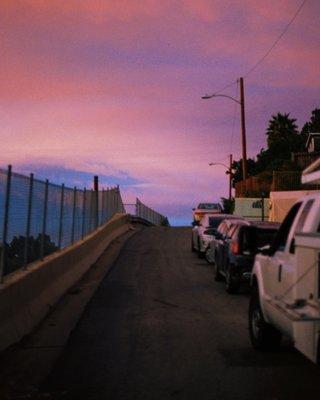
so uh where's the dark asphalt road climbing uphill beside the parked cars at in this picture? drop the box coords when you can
[41,228,320,400]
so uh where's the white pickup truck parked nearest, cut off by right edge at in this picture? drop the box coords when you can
[249,193,320,364]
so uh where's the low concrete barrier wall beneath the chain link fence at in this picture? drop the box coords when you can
[0,214,131,351]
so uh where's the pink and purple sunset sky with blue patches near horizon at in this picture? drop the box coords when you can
[0,0,320,225]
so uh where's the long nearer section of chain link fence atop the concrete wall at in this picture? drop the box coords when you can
[0,166,125,282]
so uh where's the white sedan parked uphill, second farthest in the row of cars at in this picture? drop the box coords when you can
[191,214,238,257]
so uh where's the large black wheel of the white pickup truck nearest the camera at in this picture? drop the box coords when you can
[249,288,282,351]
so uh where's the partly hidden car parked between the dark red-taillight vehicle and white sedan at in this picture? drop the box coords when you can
[205,215,249,268]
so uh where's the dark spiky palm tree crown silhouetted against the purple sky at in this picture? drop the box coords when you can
[266,113,298,148]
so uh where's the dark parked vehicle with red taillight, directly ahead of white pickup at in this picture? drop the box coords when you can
[215,221,279,293]
